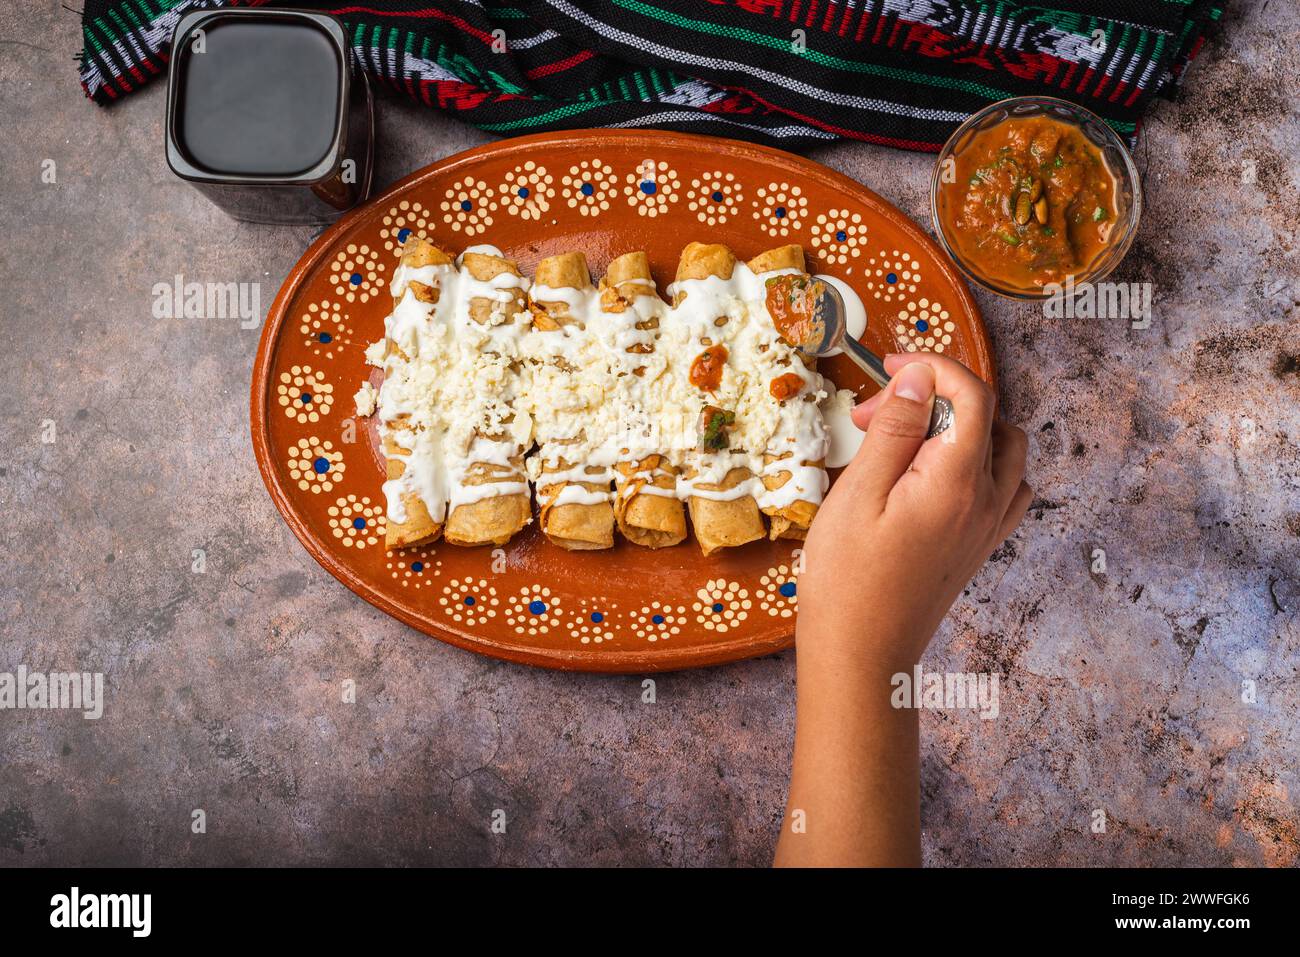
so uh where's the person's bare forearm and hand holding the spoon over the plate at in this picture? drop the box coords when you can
[776,354,1032,866]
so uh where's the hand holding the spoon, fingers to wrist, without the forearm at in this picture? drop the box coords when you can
[798,354,1032,674]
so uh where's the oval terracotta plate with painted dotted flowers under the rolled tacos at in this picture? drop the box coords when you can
[252,130,993,671]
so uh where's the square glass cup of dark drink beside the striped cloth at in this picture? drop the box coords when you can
[165,8,374,224]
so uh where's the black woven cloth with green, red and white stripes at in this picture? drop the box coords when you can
[81,0,1222,151]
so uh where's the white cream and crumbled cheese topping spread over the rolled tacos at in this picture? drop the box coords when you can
[367,246,865,521]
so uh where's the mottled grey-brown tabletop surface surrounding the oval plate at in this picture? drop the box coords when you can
[0,0,1300,865]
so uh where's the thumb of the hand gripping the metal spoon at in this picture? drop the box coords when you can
[854,363,935,499]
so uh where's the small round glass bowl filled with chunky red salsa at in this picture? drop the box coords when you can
[931,96,1141,299]
